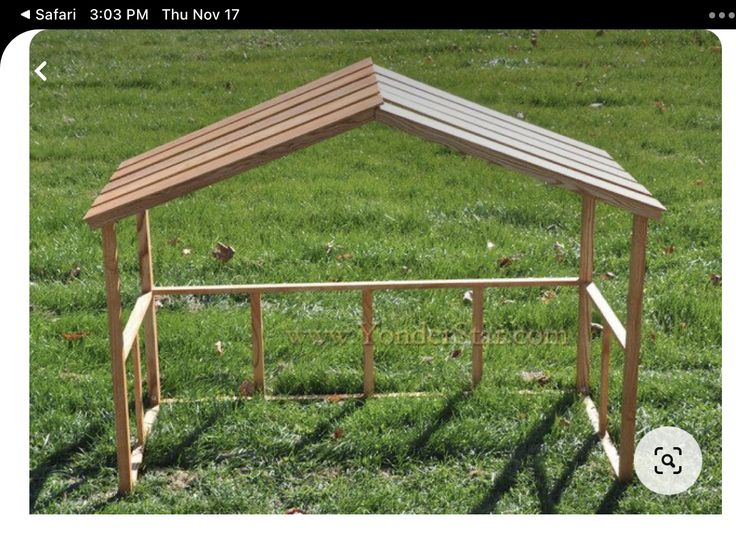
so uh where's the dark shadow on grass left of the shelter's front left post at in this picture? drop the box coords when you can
[30,422,104,513]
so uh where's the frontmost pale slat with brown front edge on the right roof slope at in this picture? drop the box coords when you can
[376,104,664,219]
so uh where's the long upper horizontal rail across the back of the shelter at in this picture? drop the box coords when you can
[154,277,580,296]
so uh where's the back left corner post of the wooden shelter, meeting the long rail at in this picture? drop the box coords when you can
[136,210,161,407]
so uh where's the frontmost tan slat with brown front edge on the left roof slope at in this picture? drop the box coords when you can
[85,95,381,228]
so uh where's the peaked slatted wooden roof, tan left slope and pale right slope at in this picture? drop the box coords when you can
[85,59,665,228]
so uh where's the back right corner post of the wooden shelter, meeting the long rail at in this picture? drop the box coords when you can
[576,195,595,394]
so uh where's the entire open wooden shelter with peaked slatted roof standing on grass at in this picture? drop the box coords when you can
[85,59,665,493]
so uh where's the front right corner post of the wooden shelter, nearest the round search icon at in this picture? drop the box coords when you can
[619,216,647,482]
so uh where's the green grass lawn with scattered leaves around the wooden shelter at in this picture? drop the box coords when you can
[29,31,721,513]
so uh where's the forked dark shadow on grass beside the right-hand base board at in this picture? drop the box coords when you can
[470,392,576,513]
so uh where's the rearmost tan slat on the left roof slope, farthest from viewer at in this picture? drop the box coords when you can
[120,58,373,168]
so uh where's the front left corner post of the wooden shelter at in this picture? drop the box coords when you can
[102,223,133,494]
